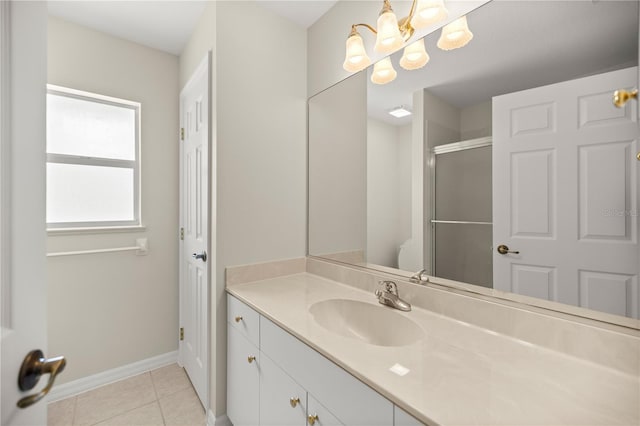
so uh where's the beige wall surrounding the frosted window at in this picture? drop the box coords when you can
[47,18,178,382]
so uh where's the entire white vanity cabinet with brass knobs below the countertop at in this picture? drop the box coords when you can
[227,295,420,426]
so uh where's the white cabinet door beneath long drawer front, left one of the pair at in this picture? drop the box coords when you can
[260,354,307,426]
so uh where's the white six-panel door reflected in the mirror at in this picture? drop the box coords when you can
[493,67,640,318]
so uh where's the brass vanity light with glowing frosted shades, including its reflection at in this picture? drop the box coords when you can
[342,0,473,84]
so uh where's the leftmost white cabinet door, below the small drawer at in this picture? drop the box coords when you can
[227,325,260,426]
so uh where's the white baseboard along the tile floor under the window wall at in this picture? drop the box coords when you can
[47,351,178,402]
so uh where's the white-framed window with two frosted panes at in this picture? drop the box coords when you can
[47,85,140,229]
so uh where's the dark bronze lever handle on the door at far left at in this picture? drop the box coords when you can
[17,349,67,408]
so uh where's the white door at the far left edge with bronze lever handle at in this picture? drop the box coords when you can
[0,2,50,426]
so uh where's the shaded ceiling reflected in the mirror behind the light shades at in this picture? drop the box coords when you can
[367,0,638,124]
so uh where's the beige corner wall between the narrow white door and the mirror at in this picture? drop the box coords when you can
[179,1,307,416]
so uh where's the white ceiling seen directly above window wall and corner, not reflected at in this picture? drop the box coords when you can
[48,0,337,55]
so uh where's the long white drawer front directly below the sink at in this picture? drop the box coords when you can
[260,317,393,426]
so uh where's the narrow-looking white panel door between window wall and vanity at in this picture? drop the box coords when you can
[180,56,212,408]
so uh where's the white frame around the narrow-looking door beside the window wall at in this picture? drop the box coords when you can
[178,50,217,412]
